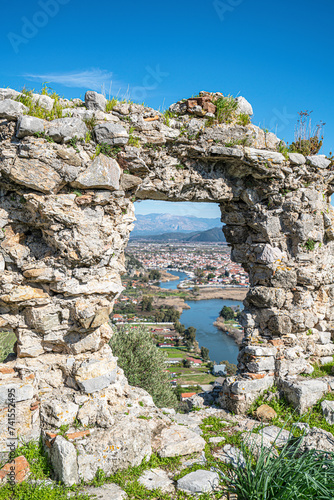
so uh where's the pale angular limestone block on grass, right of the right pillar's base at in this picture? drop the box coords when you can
[280,379,328,414]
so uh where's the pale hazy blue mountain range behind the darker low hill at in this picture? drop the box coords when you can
[132,214,221,237]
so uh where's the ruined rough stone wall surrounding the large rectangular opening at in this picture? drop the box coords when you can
[0,94,334,480]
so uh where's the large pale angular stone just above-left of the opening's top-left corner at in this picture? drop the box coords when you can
[71,155,121,191]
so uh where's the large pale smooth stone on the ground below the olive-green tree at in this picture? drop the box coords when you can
[158,425,205,457]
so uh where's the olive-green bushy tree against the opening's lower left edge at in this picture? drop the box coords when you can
[110,327,177,408]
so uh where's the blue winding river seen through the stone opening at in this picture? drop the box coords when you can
[160,271,243,364]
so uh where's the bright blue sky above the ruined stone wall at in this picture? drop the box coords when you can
[0,0,334,219]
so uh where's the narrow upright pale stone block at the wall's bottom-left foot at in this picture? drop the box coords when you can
[50,435,79,486]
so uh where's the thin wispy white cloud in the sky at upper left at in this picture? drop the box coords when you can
[23,68,119,93]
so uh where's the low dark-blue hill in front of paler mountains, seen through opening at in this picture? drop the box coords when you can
[133,227,226,243]
